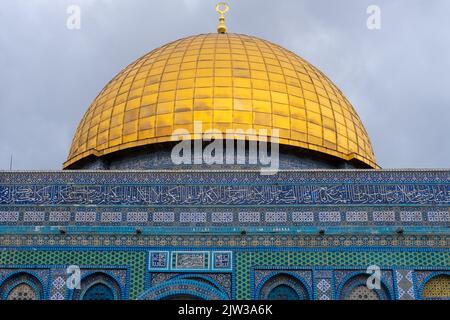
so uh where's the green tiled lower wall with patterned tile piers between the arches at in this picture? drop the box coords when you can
[0,248,450,300]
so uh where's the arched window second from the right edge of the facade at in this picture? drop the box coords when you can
[339,274,390,300]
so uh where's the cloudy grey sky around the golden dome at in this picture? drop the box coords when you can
[0,0,450,170]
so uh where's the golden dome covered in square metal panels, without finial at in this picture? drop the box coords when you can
[64,33,378,168]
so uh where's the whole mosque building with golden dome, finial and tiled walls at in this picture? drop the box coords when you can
[0,5,450,300]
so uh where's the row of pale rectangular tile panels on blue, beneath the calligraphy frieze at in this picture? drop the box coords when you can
[0,205,450,227]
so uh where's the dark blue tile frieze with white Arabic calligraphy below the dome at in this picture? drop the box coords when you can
[0,181,450,208]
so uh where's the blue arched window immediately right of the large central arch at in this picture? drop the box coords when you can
[258,274,309,300]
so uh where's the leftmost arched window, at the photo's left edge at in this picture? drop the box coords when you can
[0,272,44,300]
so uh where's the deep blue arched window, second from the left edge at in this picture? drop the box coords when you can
[72,272,122,300]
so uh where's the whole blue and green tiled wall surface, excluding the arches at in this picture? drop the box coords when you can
[0,170,450,300]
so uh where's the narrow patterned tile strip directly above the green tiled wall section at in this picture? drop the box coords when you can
[0,234,450,249]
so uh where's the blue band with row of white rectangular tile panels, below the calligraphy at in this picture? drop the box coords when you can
[0,204,450,228]
